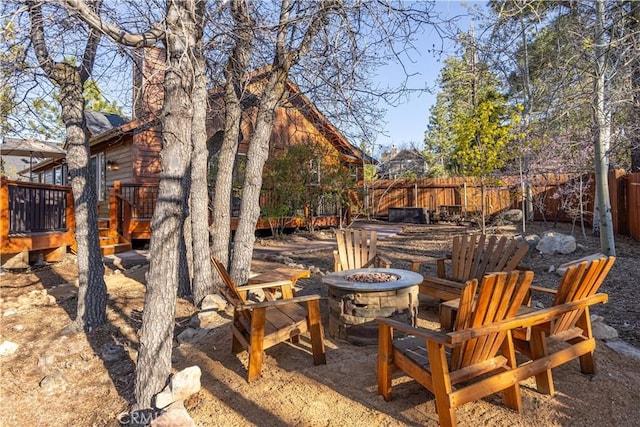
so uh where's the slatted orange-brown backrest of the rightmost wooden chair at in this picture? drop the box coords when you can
[550,257,615,335]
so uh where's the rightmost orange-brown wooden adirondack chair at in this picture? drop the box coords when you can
[513,257,615,396]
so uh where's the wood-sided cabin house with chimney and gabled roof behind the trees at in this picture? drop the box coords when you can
[0,48,375,268]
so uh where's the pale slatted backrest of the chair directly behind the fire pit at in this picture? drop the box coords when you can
[336,229,378,270]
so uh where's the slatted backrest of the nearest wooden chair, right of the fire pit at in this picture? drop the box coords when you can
[450,271,533,371]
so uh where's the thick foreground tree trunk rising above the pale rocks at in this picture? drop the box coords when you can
[134,0,198,409]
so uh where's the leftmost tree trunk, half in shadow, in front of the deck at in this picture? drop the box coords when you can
[60,75,107,331]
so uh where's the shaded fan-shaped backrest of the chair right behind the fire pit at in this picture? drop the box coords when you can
[451,234,528,282]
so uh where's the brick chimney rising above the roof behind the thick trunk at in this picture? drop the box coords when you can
[133,47,166,120]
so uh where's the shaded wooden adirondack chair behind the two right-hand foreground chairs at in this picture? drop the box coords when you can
[420,234,529,301]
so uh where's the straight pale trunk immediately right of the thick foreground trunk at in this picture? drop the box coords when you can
[190,36,216,305]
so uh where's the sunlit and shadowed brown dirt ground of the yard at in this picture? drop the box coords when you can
[0,224,640,426]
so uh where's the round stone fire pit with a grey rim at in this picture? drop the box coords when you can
[322,268,422,345]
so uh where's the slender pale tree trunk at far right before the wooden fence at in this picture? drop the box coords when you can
[593,0,616,256]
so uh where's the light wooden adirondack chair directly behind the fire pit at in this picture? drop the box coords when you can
[333,228,391,271]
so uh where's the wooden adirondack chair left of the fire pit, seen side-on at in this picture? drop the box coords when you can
[211,257,327,382]
